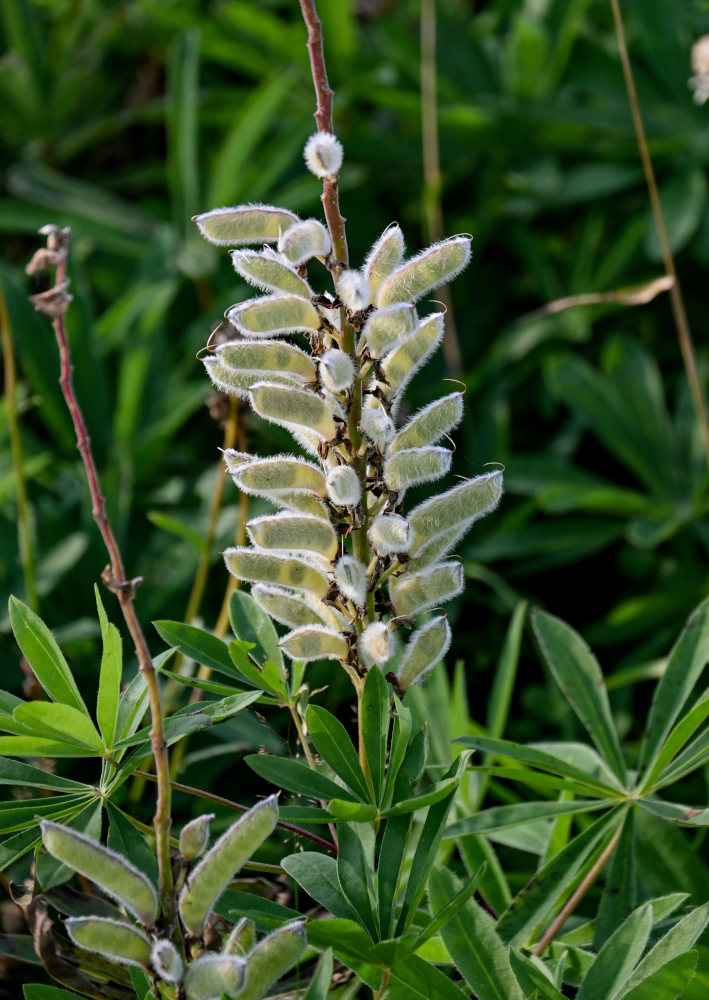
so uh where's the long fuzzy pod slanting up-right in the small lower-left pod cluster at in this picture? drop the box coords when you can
[179,795,278,936]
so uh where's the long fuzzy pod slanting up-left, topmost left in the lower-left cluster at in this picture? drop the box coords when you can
[39,819,159,926]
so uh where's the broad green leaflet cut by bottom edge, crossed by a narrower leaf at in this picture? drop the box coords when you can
[429,868,523,1000]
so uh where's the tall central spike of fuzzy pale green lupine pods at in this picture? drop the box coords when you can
[195,133,502,693]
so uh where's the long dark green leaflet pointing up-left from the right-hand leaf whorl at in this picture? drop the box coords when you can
[532,609,627,782]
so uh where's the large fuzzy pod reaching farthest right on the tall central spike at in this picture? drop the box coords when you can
[408,469,502,556]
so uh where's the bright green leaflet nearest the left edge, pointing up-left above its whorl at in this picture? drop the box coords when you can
[10,597,89,717]
